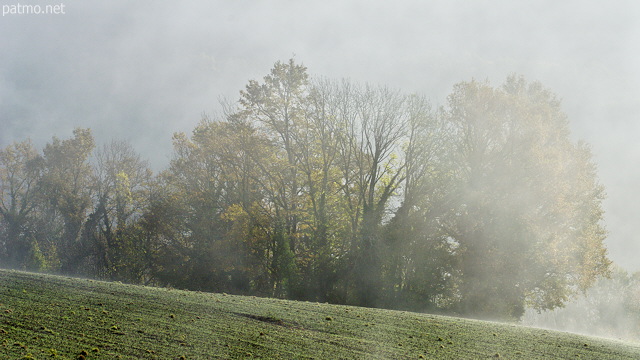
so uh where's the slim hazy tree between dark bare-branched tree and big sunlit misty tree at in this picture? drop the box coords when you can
[382,95,458,311]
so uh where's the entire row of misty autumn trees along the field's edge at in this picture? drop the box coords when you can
[0,60,609,318]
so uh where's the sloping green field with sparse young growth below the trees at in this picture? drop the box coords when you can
[0,270,640,360]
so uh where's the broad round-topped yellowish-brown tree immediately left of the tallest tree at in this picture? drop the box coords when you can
[159,116,275,295]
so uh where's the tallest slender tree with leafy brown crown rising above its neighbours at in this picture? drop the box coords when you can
[234,59,308,296]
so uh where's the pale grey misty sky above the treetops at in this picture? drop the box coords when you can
[0,0,640,271]
